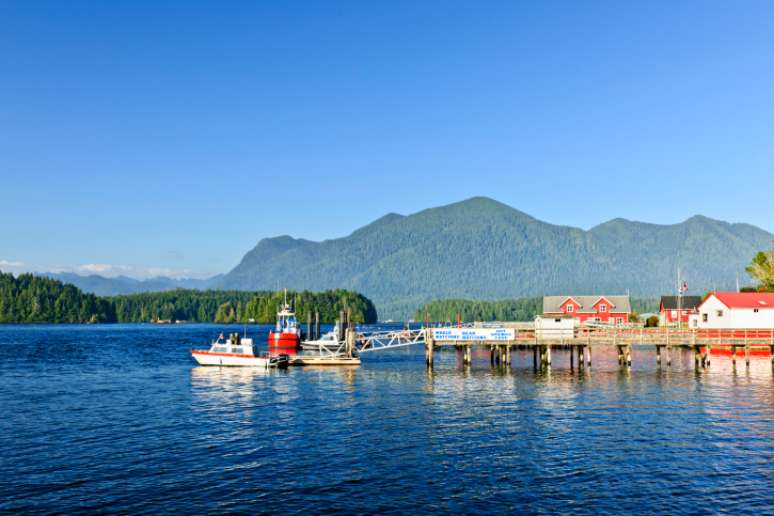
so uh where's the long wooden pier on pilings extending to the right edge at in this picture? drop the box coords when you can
[422,327,774,368]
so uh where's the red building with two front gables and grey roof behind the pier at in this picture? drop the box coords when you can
[543,296,632,324]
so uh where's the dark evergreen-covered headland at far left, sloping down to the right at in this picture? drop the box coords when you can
[0,272,116,323]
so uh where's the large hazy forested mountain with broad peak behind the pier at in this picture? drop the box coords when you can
[213,197,774,319]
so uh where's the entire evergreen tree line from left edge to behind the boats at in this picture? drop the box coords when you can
[0,272,377,323]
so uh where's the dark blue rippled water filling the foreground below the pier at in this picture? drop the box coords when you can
[0,325,774,514]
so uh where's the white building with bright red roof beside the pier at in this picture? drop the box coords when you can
[691,292,774,329]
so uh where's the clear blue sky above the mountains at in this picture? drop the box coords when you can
[0,0,774,276]
